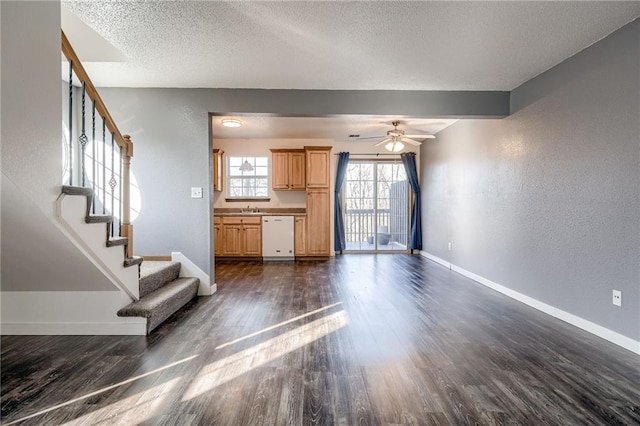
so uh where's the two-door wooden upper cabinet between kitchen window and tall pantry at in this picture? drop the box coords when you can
[271,149,306,190]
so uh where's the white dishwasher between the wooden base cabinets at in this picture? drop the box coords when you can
[262,216,295,260]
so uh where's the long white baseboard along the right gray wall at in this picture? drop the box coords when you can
[420,251,640,355]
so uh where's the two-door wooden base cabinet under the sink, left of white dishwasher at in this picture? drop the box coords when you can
[216,216,262,257]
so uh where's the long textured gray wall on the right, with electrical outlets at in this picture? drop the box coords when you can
[421,21,640,340]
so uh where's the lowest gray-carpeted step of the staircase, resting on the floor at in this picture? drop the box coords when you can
[118,277,200,334]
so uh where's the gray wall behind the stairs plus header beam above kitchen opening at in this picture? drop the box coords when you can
[99,88,509,271]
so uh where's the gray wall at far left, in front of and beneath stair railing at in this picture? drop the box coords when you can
[0,1,115,291]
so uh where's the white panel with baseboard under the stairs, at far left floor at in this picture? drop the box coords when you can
[0,291,147,336]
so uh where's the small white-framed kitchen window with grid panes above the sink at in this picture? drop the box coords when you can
[227,156,269,200]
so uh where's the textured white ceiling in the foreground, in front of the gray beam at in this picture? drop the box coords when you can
[63,1,640,90]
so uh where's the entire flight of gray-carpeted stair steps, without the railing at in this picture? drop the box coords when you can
[61,185,200,334]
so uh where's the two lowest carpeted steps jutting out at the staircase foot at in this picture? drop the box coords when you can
[118,261,200,334]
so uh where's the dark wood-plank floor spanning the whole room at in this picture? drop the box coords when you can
[2,254,640,425]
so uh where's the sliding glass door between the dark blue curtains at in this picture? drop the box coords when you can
[342,160,409,252]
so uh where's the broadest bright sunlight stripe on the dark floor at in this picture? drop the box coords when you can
[182,310,349,401]
